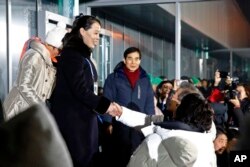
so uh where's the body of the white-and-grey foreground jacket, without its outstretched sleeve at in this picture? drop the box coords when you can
[128,126,216,167]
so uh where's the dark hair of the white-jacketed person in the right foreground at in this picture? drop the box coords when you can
[175,93,213,131]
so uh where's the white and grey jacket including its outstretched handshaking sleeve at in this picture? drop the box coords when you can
[116,107,216,167]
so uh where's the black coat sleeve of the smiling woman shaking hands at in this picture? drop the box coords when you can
[61,51,110,114]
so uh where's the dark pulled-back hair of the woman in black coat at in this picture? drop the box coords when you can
[63,13,101,46]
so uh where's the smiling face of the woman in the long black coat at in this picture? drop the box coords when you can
[80,22,101,49]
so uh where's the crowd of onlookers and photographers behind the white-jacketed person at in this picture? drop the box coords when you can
[142,70,250,167]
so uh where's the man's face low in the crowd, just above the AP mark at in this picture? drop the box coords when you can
[214,133,227,154]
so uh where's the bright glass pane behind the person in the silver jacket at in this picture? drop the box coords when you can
[10,0,36,88]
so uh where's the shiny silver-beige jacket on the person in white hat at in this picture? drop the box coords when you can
[4,40,56,120]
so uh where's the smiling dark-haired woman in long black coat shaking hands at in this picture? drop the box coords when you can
[51,15,117,167]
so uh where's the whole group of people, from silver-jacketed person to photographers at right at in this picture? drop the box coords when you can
[0,14,250,167]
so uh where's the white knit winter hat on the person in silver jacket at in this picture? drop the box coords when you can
[45,22,67,48]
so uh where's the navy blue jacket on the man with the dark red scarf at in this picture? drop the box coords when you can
[103,62,155,122]
